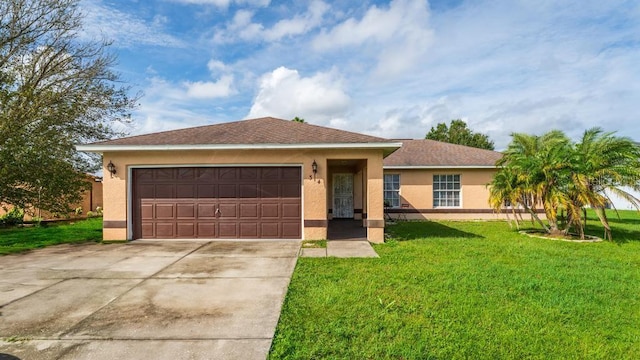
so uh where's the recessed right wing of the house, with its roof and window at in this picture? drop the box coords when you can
[383,140,502,219]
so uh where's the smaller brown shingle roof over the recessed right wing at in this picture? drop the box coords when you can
[384,140,502,167]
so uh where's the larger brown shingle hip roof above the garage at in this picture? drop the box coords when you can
[91,117,393,146]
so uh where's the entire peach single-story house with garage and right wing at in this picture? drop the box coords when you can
[77,118,500,242]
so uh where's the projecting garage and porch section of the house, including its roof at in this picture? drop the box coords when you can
[78,118,401,242]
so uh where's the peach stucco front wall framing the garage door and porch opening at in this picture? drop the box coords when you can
[103,149,384,241]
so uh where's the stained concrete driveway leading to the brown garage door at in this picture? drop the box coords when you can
[0,241,300,360]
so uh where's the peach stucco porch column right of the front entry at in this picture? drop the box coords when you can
[366,153,384,243]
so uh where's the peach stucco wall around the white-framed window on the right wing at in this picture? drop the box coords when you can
[384,169,496,219]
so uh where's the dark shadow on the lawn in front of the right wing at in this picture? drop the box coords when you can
[385,221,484,241]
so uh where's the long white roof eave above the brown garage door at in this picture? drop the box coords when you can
[76,142,402,153]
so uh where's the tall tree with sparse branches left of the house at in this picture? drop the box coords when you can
[0,0,137,217]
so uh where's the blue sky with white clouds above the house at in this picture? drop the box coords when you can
[80,0,640,150]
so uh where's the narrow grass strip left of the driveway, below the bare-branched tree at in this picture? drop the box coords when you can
[0,218,102,255]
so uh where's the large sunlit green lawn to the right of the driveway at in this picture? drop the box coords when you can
[270,212,640,359]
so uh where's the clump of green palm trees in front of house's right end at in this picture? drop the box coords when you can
[490,128,640,240]
